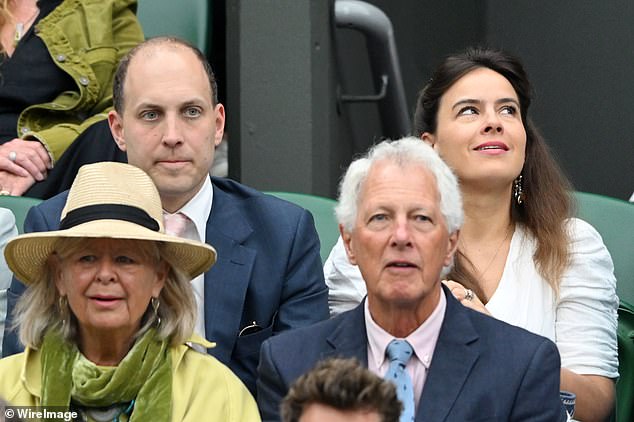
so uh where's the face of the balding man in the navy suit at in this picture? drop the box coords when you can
[108,43,225,212]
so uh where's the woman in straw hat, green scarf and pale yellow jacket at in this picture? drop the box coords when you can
[0,163,259,421]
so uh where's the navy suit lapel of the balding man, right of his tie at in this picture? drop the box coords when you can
[205,186,256,363]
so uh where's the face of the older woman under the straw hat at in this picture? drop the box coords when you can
[52,239,167,359]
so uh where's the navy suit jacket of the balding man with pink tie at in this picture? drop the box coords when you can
[3,178,328,392]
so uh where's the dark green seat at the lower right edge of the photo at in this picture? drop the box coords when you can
[616,300,634,422]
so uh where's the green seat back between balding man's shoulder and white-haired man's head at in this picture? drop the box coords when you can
[267,192,339,263]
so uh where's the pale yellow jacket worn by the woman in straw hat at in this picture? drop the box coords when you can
[0,336,260,422]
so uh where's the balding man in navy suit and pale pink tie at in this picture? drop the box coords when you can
[3,37,328,391]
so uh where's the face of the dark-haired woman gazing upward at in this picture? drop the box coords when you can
[422,68,526,189]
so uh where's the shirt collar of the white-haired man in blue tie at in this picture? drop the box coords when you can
[364,289,447,369]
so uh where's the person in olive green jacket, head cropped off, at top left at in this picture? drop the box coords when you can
[0,0,143,199]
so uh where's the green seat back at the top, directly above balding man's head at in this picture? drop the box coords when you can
[137,0,211,55]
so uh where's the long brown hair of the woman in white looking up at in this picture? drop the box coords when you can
[414,48,572,297]
